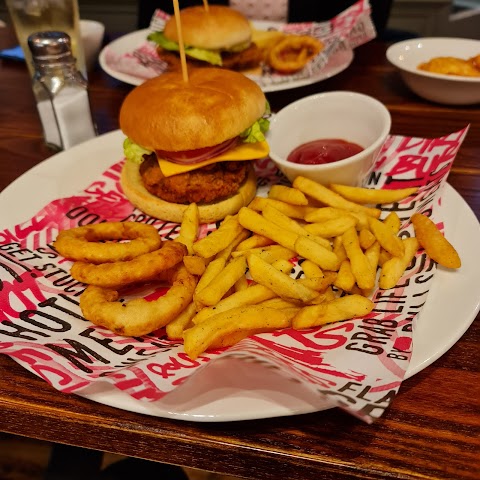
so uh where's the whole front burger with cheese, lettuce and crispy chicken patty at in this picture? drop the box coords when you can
[119,68,269,223]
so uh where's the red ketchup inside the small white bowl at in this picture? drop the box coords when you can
[287,138,363,165]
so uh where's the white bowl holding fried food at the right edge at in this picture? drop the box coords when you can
[387,37,480,105]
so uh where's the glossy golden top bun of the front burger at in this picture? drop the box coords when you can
[120,68,266,152]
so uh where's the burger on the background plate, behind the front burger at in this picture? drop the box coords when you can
[148,5,262,71]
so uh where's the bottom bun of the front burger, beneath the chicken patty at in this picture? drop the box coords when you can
[120,161,257,223]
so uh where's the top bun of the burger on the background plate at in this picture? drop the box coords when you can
[163,5,252,50]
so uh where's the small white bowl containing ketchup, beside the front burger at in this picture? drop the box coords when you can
[267,91,391,186]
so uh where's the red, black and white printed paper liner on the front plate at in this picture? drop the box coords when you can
[0,127,468,422]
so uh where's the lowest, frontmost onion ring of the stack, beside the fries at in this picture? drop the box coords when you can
[80,264,197,337]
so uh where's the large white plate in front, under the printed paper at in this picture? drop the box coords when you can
[0,130,480,422]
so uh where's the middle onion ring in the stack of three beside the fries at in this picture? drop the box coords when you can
[70,241,188,288]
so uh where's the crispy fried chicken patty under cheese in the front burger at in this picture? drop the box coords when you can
[140,154,248,205]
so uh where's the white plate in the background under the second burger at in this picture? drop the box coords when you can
[98,26,353,92]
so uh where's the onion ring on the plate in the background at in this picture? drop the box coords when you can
[268,35,324,73]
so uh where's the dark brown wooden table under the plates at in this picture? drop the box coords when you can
[0,29,480,480]
